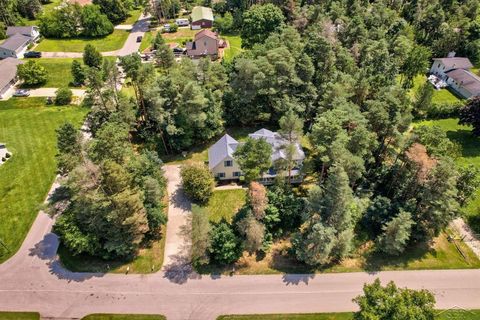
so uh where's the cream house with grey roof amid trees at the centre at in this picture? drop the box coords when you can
[208,129,305,184]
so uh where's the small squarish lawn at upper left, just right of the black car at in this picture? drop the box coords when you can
[20,58,83,88]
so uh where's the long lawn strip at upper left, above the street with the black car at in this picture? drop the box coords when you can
[34,30,129,52]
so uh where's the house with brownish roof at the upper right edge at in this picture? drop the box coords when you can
[430,57,480,99]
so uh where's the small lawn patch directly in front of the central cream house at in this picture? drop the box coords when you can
[196,189,246,222]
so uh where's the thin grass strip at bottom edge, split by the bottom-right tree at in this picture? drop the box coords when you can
[217,310,480,320]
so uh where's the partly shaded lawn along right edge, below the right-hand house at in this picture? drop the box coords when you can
[415,118,480,234]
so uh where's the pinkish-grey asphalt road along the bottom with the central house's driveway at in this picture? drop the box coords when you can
[0,166,480,320]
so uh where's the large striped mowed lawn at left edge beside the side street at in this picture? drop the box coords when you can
[0,98,87,263]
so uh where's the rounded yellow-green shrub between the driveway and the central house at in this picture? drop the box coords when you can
[180,163,215,203]
